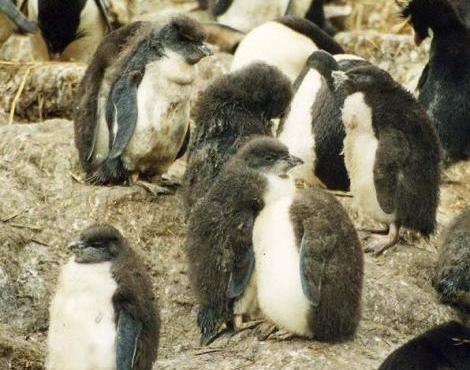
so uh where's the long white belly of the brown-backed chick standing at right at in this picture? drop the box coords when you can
[342,92,395,224]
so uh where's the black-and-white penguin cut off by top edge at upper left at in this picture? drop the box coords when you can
[28,0,110,63]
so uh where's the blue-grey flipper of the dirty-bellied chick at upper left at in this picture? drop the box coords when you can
[106,71,143,159]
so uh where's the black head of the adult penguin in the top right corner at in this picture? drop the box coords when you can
[401,0,466,34]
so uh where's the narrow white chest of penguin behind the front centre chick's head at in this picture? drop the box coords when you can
[279,69,322,186]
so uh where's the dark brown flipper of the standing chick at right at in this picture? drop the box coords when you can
[374,129,410,214]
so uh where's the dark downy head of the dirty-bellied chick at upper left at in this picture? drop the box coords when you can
[160,16,213,65]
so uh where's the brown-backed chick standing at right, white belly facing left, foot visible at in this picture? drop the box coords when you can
[321,54,440,254]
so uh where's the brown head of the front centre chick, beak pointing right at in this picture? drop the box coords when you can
[237,136,304,178]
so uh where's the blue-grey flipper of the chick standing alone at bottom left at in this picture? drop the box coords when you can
[116,310,142,370]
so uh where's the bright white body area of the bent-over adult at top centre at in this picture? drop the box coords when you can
[231,21,318,81]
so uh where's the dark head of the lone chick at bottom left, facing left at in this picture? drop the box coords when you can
[68,224,124,263]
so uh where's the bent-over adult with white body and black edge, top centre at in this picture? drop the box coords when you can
[231,16,343,81]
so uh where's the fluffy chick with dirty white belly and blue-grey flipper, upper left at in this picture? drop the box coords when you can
[75,17,211,193]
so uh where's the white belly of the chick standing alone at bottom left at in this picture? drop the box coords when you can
[46,259,117,370]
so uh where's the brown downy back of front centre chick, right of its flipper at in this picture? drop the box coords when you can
[290,189,364,342]
